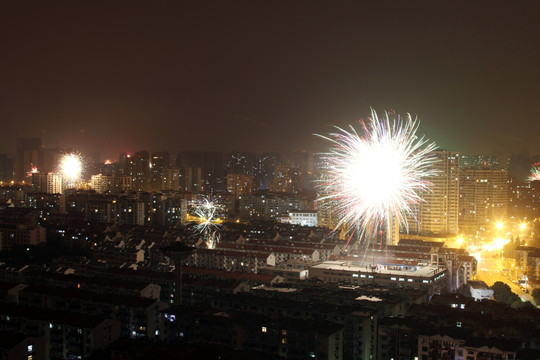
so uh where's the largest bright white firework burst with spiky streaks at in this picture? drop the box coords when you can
[319,110,436,245]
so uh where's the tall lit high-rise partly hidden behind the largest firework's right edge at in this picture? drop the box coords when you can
[408,150,459,235]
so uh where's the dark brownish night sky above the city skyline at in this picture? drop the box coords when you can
[0,0,540,159]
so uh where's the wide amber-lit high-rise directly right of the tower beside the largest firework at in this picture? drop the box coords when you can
[459,169,508,232]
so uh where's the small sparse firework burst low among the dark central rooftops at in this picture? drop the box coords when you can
[192,196,223,248]
